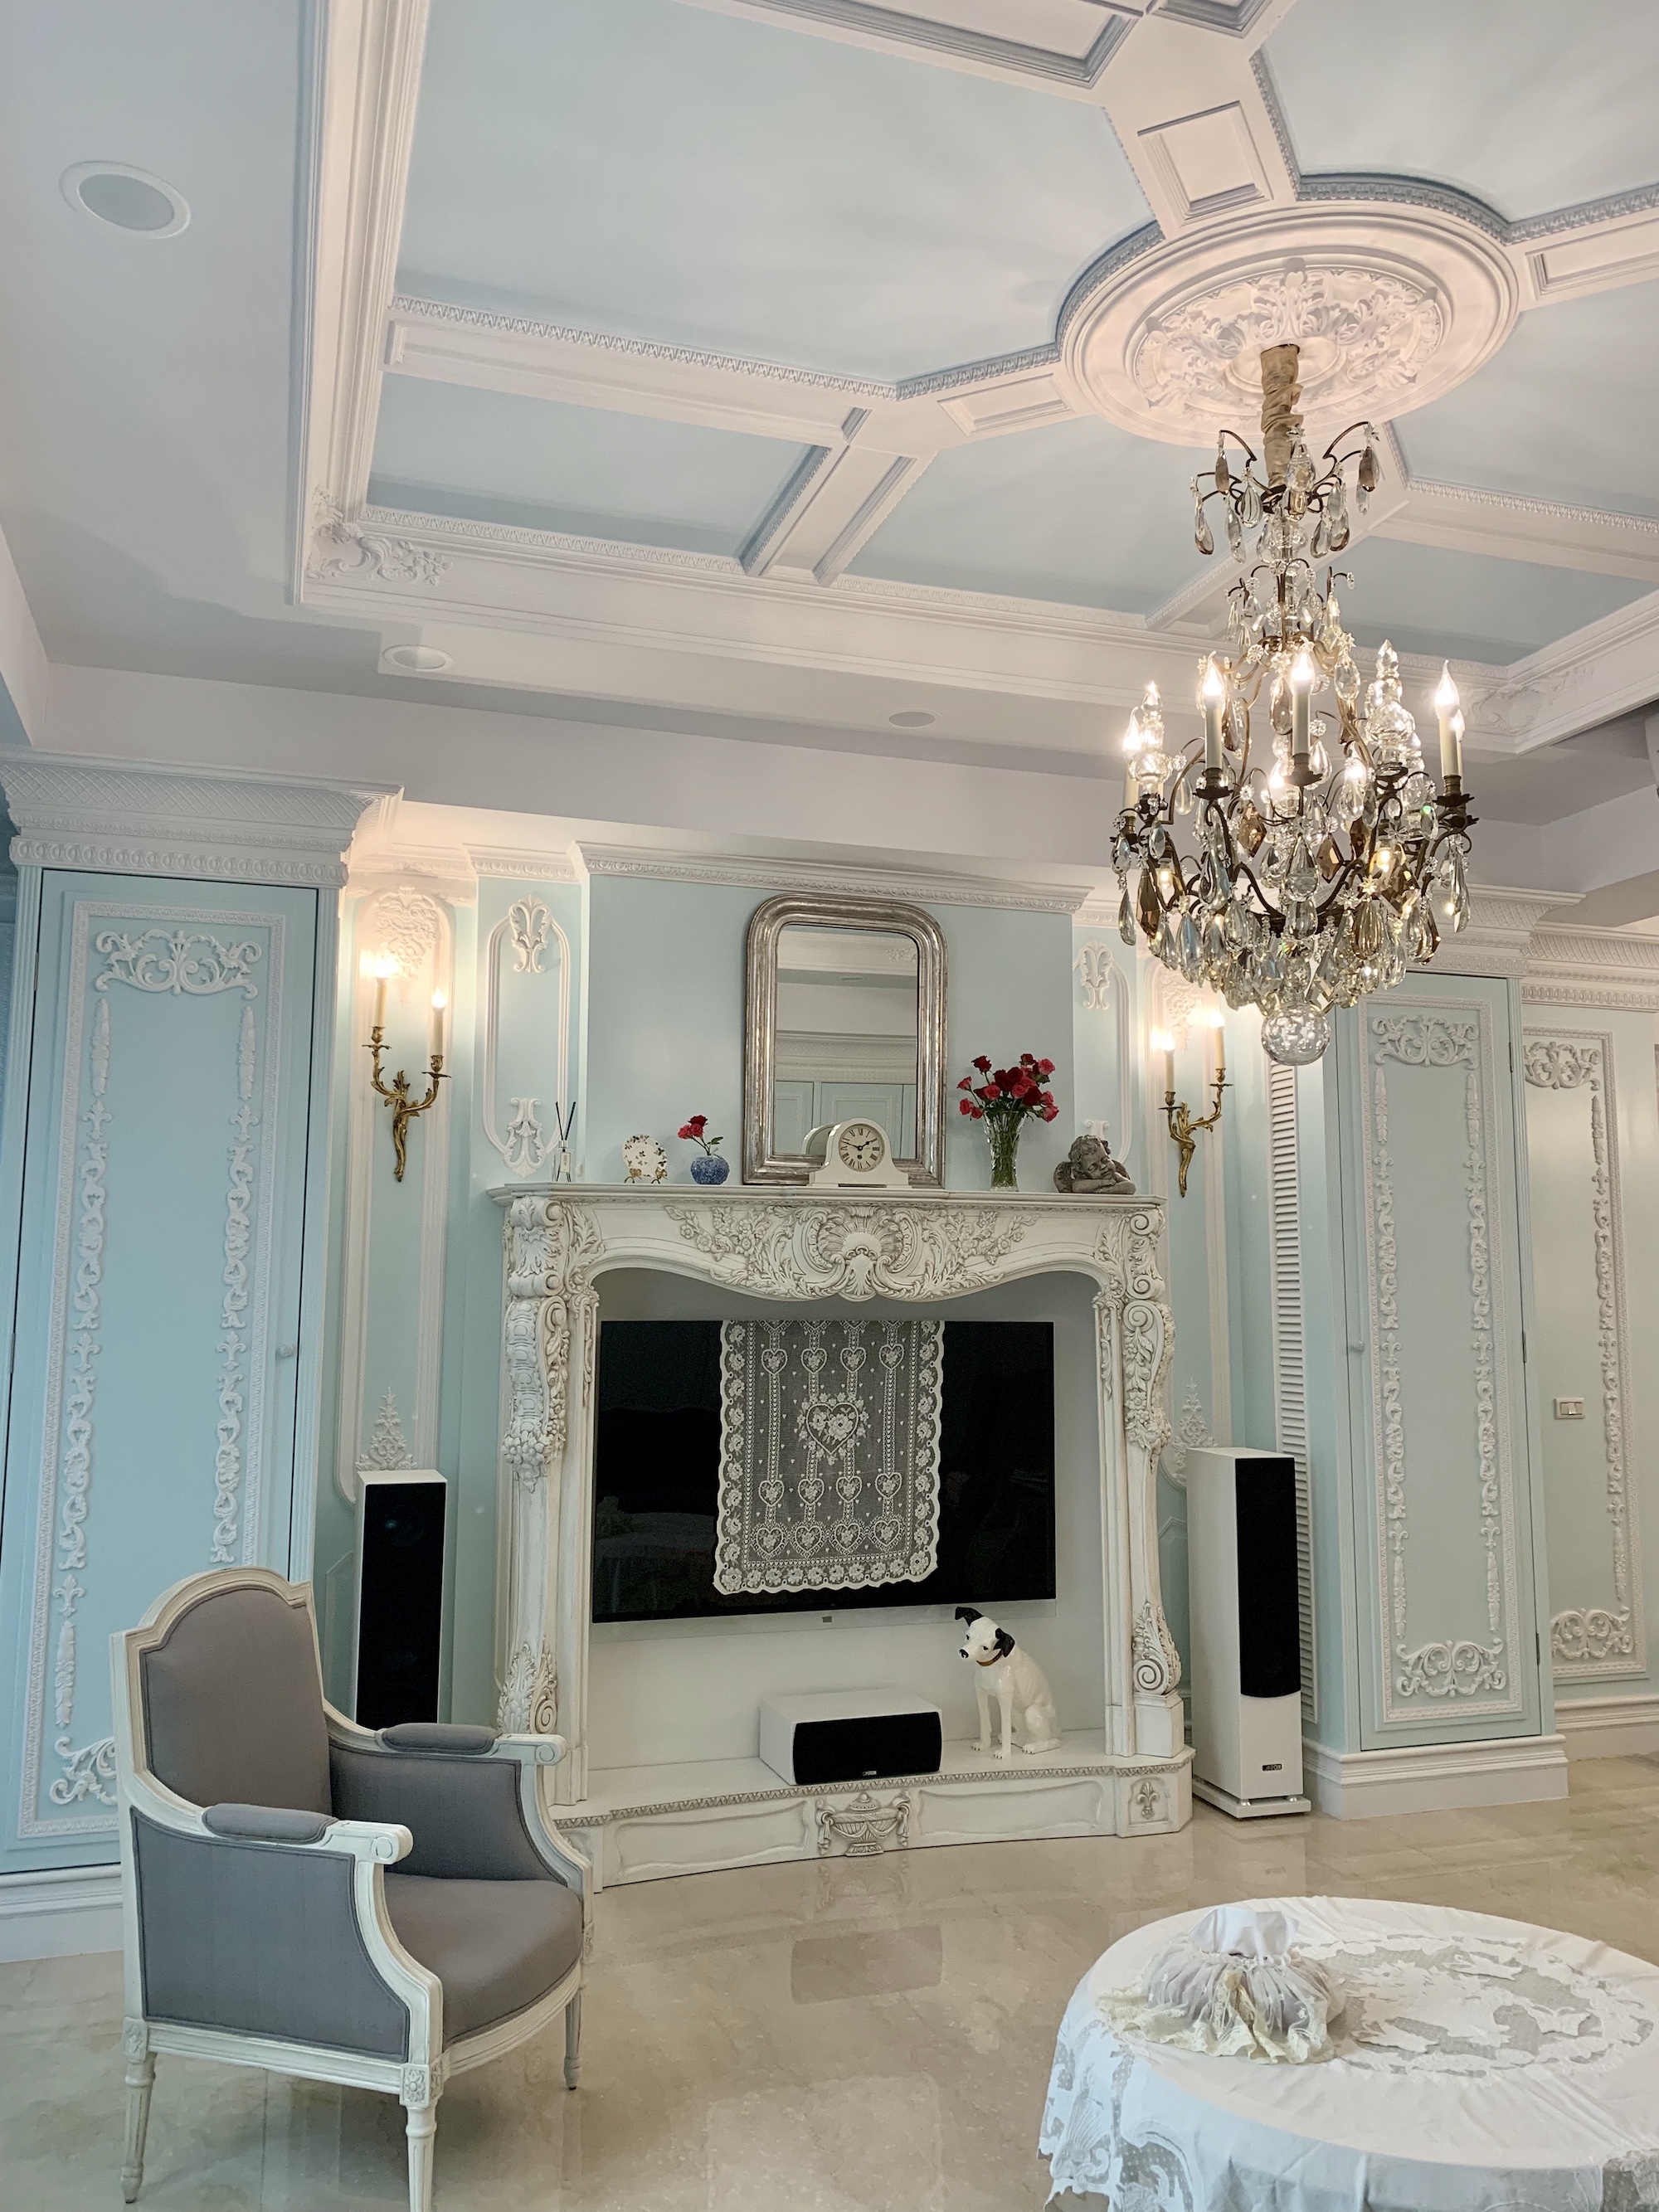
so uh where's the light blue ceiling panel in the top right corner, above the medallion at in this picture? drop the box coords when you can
[1267,0,1659,221]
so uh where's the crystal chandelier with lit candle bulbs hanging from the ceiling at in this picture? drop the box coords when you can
[1112,345,1476,1066]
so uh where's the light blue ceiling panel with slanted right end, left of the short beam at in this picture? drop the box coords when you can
[369,376,807,553]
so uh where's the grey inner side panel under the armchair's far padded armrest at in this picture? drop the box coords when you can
[332,1741,557,1884]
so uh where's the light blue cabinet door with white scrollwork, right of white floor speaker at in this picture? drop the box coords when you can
[1338,975,1540,1750]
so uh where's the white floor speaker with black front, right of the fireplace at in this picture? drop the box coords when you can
[1185,1445,1310,1821]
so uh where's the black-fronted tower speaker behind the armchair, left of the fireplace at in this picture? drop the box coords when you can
[352,1466,449,1728]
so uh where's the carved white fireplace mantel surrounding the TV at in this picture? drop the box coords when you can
[491,1184,1185,1825]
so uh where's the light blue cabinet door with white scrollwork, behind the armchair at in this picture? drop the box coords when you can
[0,869,319,1867]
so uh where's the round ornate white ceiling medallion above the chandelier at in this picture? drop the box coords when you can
[1059,199,1520,445]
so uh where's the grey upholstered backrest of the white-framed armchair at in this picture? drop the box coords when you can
[139,1588,332,1814]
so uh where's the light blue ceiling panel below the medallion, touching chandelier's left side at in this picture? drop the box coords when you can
[854,416,1205,615]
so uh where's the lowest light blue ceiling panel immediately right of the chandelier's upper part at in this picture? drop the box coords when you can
[1336,537,1648,668]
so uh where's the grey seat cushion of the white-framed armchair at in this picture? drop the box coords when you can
[385,1874,581,2044]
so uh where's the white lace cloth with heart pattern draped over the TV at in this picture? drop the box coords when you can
[714,1320,945,1595]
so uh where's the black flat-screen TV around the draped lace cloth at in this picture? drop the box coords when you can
[593,1320,1055,1621]
